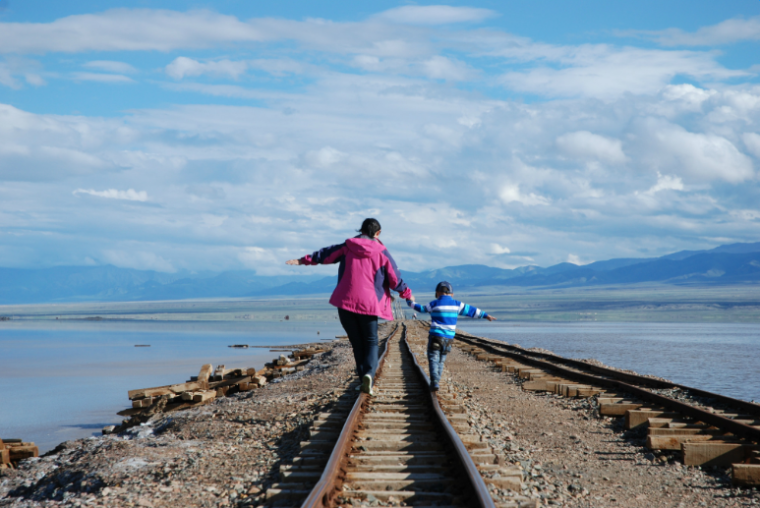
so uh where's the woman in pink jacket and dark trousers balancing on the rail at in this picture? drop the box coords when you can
[287,219,412,395]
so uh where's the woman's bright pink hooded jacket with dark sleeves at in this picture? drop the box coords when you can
[301,235,412,321]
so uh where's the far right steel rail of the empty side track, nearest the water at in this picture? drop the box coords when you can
[457,332,760,417]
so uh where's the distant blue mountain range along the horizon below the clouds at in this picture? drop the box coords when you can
[0,242,760,304]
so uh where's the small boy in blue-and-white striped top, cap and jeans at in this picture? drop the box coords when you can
[406,281,496,392]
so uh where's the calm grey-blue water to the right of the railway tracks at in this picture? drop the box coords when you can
[460,320,760,401]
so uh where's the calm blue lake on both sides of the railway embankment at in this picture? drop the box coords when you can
[0,313,760,452]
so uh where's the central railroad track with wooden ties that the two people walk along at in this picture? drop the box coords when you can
[267,323,537,508]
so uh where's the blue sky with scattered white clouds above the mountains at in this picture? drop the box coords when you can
[0,0,760,274]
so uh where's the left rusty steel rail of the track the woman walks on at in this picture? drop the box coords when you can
[301,324,403,508]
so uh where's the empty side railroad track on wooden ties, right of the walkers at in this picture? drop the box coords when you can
[446,332,760,486]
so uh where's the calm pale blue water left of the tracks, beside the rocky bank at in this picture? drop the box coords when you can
[0,321,343,452]
